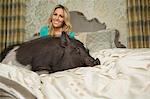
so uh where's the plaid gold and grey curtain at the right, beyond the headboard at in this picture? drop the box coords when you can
[127,0,150,48]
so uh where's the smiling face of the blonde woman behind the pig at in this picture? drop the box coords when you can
[52,8,64,28]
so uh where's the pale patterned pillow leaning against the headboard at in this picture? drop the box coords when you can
[75,29,116,52]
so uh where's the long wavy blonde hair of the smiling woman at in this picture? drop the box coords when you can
[48,5,72,36]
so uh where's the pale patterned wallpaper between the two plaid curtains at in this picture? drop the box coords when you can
[25,0,127,45]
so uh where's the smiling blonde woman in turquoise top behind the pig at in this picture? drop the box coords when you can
[40,5,74,38]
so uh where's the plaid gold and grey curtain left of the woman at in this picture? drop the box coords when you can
[0,0,25,53]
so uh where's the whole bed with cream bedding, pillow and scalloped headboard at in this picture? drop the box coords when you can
[0,11,150,99]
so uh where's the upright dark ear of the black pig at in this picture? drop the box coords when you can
[61,32,70,47]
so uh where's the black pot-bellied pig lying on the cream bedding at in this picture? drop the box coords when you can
[5,32,100,73]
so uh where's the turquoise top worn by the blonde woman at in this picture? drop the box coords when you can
[39,25,75,38]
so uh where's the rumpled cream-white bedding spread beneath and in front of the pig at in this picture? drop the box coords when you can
[0,49,150,99]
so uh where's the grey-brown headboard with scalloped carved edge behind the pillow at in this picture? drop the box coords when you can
[70,11,126,48]
